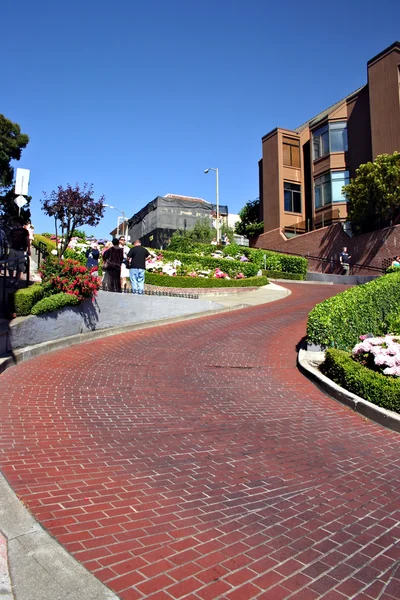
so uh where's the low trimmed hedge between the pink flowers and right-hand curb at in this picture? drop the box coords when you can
[321,348,400,413]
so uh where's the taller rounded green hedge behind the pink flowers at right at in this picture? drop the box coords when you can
[307,273,400,351]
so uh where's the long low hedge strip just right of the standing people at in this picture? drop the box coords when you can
[145,271,268,288]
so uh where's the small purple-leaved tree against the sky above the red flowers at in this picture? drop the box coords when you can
[42,183,105,256]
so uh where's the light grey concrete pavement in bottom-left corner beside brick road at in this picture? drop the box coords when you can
[0,475,118,600]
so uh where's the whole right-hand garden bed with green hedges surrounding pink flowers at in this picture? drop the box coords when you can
[307,270,400,413]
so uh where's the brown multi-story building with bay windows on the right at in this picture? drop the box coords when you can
[259,42,400,237]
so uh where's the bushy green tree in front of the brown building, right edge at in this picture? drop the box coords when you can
[343,152,400,233]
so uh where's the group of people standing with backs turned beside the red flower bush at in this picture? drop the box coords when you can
[86,235,150,294]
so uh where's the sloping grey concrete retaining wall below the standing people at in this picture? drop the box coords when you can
[8,291,221,350]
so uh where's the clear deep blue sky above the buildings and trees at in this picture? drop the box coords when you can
[0,0,400,237]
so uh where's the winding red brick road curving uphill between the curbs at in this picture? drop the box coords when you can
[0,284,400,600]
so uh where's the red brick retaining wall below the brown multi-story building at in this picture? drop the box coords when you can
[254,223,400,275]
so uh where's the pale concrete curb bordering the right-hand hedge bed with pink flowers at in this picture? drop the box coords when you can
[297,349,400,433]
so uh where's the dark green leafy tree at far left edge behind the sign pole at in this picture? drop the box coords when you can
[0,115,31,221]
